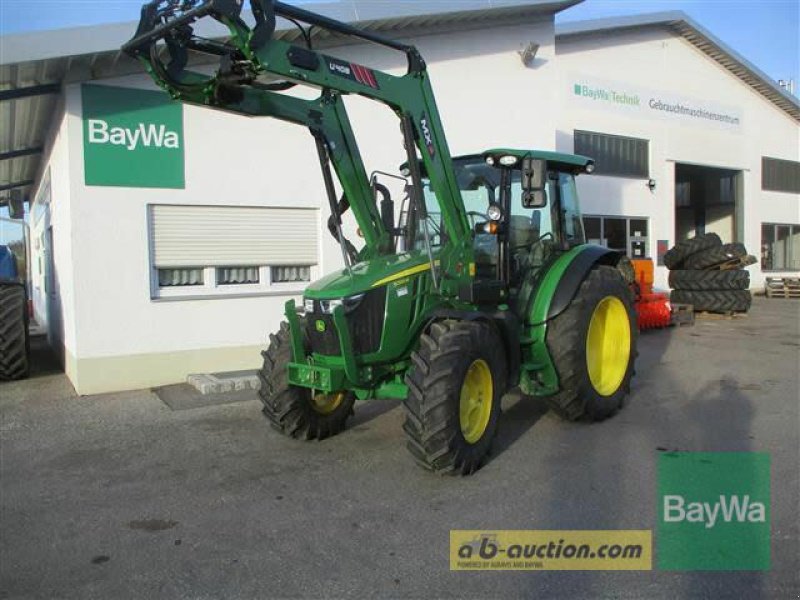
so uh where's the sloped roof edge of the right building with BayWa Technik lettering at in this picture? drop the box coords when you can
[556,11,800,121]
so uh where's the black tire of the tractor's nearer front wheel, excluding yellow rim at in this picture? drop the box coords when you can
[403,320,508,475]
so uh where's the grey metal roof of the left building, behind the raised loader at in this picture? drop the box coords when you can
[0,0,583,205]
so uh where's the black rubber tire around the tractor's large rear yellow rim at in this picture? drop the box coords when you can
[546,265,638,421]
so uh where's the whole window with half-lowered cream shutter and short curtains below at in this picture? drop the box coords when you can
[148,205,319,297]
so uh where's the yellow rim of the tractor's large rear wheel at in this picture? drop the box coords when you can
[586,296,631,396]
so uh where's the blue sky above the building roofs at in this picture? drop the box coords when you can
[0,0,800,86]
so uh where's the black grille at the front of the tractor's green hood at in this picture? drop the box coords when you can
[306,286,386,356]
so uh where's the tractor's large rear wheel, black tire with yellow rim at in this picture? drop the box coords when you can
[547,266,637,421]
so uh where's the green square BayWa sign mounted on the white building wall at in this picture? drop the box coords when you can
[81,85,185,189]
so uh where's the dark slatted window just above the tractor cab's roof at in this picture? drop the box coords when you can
[575,129,650,179]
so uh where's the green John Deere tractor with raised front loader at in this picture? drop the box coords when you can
[123,0,637,474]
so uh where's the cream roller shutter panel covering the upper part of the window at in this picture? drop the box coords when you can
[149,205,319,267]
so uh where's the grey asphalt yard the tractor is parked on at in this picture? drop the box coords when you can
[0,298,800,599]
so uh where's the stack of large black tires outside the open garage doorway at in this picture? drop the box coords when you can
[664,233,753,313]
